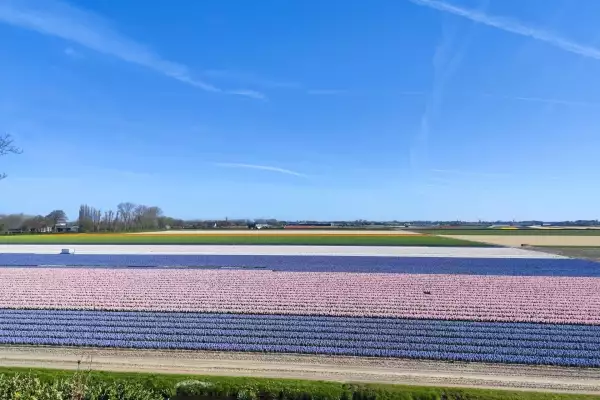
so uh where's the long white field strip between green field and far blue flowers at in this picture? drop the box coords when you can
[0,244,564,259]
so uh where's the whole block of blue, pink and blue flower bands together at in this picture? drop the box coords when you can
[0,247,600,367]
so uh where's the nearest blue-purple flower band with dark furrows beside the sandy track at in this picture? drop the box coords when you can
[0,310,600,367]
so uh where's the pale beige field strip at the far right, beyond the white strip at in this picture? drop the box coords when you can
[440,235,600,247]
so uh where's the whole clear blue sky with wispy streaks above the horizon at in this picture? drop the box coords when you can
[0,0,600,220]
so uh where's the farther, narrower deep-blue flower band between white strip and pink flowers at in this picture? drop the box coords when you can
[0,253,600,277]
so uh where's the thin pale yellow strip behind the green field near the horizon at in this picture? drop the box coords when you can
[129,229,421,236]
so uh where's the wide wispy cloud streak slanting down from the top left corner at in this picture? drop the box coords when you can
[0,0,264,98]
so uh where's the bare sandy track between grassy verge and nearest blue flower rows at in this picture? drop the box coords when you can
[0,346,600,394]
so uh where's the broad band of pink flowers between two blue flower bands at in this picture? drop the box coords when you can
[0,268,600,324]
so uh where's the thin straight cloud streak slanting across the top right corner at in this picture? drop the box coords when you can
[409,0,600,60]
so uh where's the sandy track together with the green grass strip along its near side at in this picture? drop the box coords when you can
[0,346,600,400]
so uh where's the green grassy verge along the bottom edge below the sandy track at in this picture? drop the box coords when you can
[0,368,599,400]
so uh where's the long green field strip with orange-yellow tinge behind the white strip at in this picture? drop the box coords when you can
[0,234,489,247]
